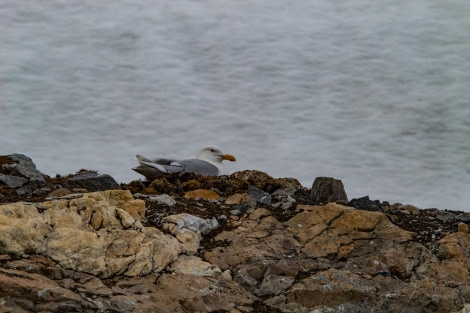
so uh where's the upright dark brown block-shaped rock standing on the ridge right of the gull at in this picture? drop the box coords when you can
[310,177,348,203]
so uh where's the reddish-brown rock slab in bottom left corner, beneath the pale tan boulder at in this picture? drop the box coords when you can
[0,256,254,313]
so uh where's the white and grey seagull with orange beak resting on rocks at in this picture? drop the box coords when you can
[133,146,236,180]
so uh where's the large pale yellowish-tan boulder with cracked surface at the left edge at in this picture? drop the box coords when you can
[0,191,181,277]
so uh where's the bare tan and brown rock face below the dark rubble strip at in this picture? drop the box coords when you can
[0,191,470,312]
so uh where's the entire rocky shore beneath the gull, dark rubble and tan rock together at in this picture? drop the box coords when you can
[0,154,470,313]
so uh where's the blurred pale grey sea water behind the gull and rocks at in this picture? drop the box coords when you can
[0,0,470,211]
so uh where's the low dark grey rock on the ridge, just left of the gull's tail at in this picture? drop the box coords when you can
[64,171,121,191]
